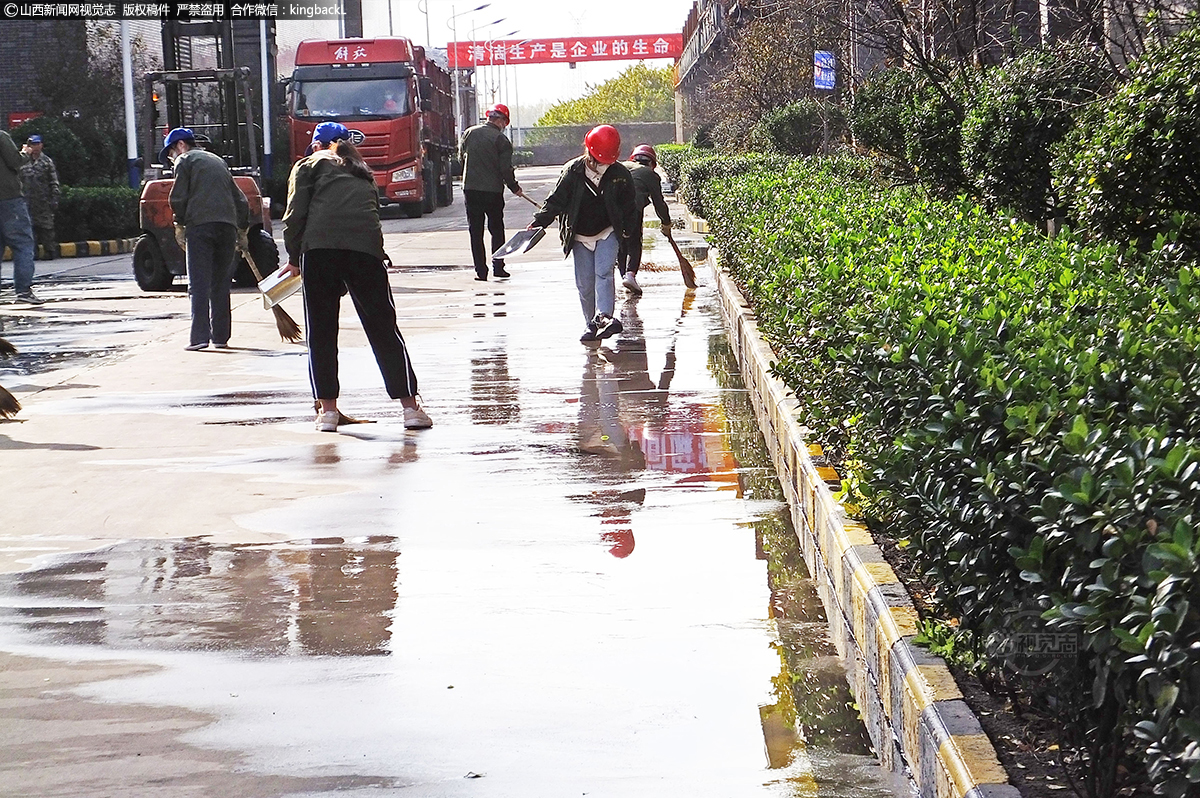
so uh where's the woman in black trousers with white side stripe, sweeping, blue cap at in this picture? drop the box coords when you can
[283,122,433,432]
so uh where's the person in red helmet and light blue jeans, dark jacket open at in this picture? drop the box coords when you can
[529,125,641,343]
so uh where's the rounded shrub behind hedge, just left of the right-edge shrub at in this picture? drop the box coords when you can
[962,47,1114,222]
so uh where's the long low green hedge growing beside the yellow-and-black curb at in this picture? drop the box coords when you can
[691,152,1200,798]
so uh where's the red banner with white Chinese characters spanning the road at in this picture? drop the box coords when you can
[449,34,683,70]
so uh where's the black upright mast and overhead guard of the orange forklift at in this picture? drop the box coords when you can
[145,19,258,178]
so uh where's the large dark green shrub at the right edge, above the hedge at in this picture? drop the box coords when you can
[1060,25,1200,257]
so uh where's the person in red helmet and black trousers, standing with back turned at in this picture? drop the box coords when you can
[458,103,524,280]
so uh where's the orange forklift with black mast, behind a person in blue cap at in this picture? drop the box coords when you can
[133,20,280,290]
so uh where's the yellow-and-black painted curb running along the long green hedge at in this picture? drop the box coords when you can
[692,244,1020,798]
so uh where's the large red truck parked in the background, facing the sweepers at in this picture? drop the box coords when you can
[288,37,457,218]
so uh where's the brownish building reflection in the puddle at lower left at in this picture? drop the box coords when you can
[0,536,400,656]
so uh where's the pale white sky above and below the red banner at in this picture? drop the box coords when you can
[362,0,691,125]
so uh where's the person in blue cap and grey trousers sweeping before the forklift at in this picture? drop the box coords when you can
[160,127,250,352]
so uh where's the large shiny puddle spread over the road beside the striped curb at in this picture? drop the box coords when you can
[0,260,898,798]
